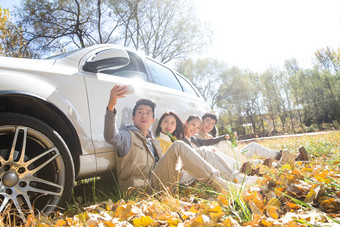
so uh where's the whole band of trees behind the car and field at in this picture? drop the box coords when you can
[0,0,340,139]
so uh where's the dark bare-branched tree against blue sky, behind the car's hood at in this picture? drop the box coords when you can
[18,0,120,54]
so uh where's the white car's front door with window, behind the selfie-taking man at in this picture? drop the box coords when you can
[83,48,164,172]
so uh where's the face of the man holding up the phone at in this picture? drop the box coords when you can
[132,105,155,133]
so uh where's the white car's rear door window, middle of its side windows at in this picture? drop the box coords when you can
[146,59,183,91]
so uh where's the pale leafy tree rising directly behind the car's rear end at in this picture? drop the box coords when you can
[176,58,227,110]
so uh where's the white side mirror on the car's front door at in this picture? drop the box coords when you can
[83,49,130,73]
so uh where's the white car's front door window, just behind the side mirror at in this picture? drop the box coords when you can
[100,52,148,81]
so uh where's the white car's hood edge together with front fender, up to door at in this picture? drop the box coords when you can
[0,58,94,154]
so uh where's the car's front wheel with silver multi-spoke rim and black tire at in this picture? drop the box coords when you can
[0,113,74,221]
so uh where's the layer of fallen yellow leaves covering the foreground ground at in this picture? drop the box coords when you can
[14,134,340,227]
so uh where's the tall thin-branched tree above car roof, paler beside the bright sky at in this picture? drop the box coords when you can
[114,0,211,63]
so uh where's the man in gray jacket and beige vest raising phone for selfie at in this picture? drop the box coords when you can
[104,85,257,190]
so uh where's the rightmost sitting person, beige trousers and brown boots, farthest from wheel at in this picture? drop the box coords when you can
[195,113,308,172]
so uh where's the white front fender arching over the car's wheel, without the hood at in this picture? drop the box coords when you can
[0,71,94,154]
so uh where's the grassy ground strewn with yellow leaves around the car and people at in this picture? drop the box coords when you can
[3,131,340,226]
